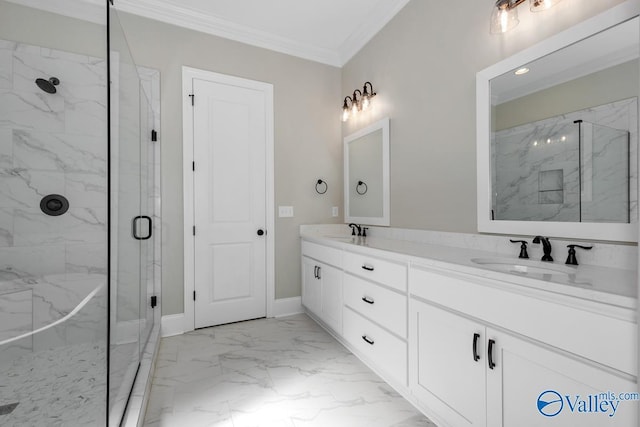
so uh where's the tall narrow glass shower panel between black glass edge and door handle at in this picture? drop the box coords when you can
[109,7,146,426]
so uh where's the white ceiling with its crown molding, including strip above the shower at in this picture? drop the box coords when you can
[7,0,410,67]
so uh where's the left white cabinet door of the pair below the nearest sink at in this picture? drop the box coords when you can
[409,299,486,426]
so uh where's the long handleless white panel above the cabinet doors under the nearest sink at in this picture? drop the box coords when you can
[410,267,638,375]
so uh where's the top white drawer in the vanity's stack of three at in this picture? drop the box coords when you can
[344,252,407,292]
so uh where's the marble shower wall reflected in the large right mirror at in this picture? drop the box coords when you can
[492,98,638,222]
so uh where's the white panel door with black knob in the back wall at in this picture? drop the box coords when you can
[193,79,267,328]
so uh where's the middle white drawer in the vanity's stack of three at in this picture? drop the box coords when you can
[343,274,407,338]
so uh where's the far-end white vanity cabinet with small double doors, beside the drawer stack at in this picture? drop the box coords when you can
[302,241,342,334]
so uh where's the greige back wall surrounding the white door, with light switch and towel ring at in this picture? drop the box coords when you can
[120,13,342,315]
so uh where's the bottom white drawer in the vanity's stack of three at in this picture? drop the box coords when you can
[342,307,407,386]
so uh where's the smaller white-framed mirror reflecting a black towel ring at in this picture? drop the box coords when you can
[344,118,389,226]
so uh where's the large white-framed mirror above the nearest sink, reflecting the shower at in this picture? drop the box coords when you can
[476,2,640,242]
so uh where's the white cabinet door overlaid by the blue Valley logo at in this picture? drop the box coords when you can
[487,329,638,427]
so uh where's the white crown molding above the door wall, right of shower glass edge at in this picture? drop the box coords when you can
[115,0,342,67]
